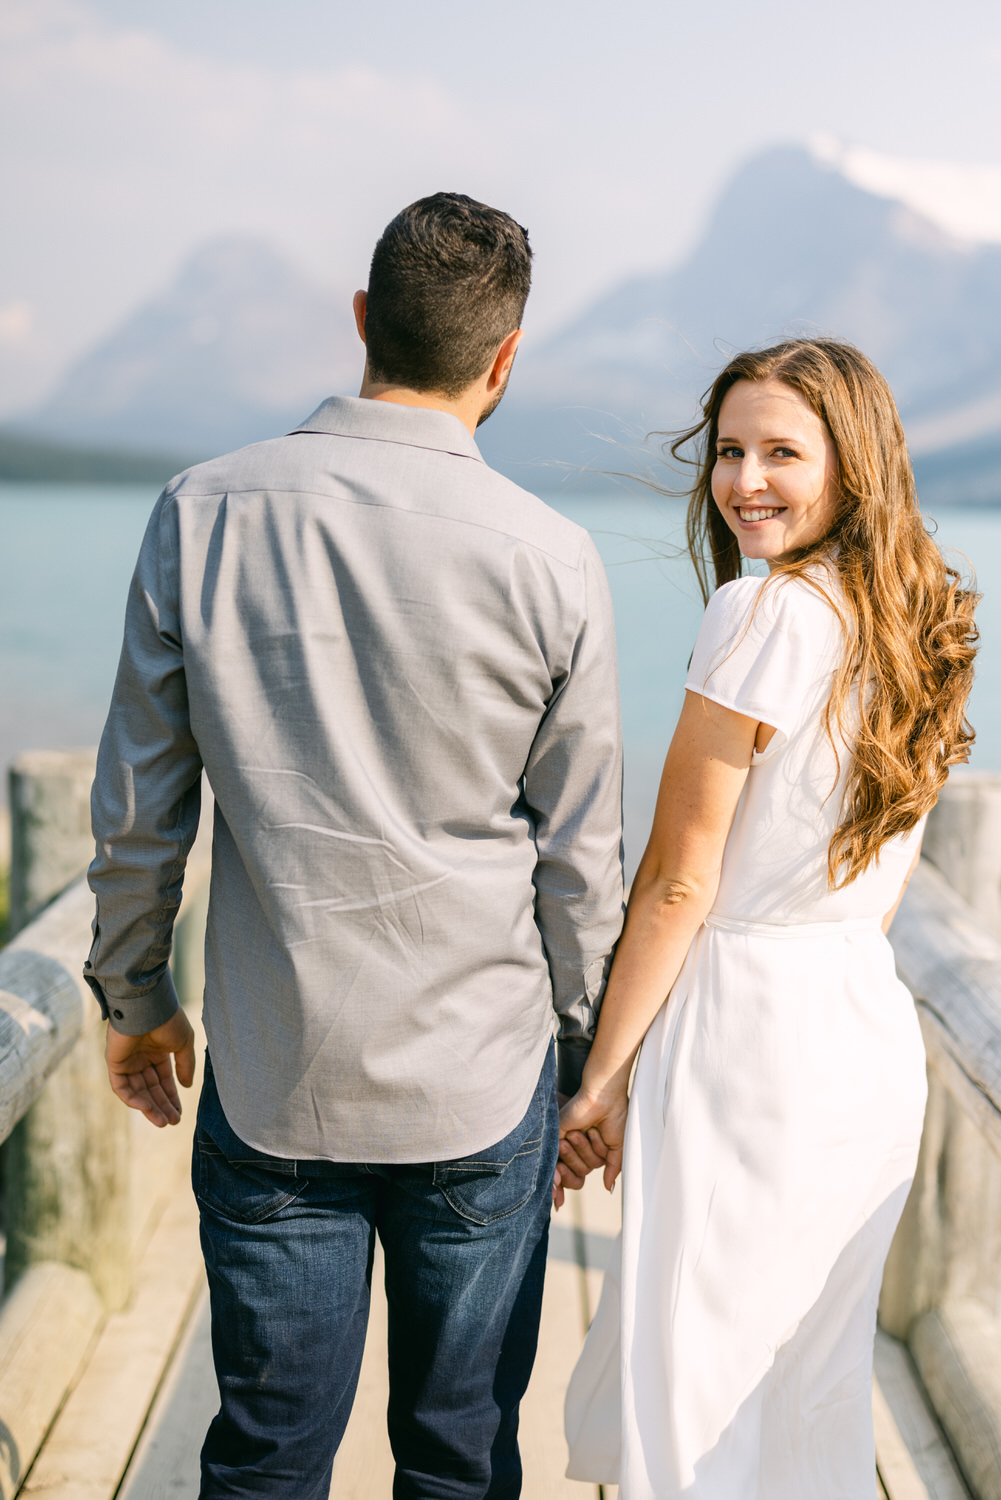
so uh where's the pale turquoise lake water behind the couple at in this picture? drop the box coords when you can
[0,485,1001,870]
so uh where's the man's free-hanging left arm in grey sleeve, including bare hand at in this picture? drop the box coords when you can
[84,495,201,1125]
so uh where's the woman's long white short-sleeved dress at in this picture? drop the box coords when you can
[566,578,924,1500]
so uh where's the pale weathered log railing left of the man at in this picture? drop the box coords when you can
[0,752,212,1500]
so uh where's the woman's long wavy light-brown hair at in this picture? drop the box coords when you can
[671,339,980,888]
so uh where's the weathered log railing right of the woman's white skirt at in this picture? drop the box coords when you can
[879,773,1001,1500]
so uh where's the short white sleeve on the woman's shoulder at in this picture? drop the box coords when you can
[684,578,840,756]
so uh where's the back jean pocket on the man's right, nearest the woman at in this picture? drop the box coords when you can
[434,1088,546,1224]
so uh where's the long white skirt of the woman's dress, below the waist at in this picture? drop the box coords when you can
[567,917,926,1500]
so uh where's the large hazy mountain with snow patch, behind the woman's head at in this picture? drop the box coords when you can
[483,149,1001,500]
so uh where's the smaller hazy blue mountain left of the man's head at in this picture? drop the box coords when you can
[21,236,362,458]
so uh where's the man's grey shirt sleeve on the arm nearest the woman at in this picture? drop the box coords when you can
[525,539,623,1095]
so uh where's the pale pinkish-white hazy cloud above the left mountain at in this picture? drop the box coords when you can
[0,0,497,407]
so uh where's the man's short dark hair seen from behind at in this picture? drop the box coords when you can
[365,192,531,399]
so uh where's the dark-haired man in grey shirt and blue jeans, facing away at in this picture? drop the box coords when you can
[87,194,621,1500]
